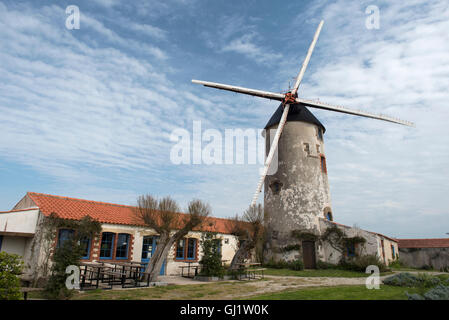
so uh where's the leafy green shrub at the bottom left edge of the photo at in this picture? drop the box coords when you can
[0,252,22,300]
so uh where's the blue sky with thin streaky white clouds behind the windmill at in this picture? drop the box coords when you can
[0,0,449,238]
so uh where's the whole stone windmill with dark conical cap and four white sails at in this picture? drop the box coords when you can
[192,21,414,261]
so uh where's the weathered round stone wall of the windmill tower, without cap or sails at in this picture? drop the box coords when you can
[264,121,331,260]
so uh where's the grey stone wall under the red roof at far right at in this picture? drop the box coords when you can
[399,248,449,270]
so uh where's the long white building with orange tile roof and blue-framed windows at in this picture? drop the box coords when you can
[0,192,238,276]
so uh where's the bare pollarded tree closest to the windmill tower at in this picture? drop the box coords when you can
[227,204,264,270]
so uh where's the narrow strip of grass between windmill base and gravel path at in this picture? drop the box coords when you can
[265,268,392,278]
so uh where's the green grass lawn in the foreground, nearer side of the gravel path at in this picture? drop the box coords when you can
[250,285,418,300]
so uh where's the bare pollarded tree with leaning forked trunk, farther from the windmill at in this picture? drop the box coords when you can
[136,195,211,281]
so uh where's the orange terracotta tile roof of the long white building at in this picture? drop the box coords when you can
[27,192,233,234]
